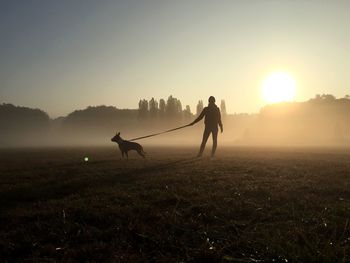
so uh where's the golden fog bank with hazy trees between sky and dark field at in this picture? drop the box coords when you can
[0,95,350,147]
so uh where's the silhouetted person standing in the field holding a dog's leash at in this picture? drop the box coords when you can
[189,96,224,157]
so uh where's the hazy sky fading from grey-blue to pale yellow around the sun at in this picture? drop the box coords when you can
[0,0,350,117]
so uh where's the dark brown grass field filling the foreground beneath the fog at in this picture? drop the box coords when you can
[0,147,350,262]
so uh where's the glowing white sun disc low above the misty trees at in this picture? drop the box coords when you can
[262,72,296,103]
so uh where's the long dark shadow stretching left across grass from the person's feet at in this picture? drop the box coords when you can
[0,158,198,212]
